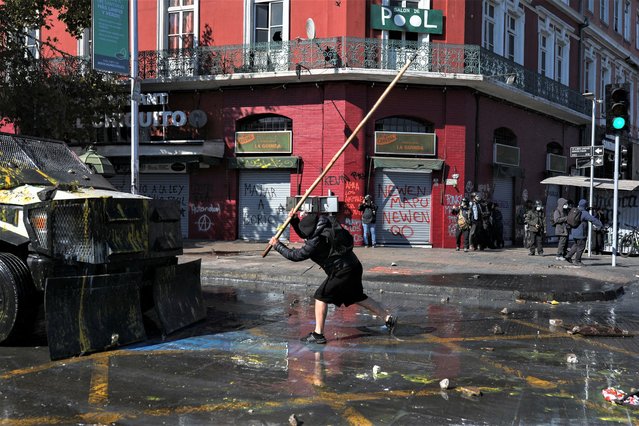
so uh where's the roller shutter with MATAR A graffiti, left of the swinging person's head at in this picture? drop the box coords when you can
[239,170,291,241]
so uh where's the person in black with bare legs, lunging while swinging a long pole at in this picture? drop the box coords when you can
[270,213,397,344]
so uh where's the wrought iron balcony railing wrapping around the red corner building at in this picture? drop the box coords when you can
[139,37,590,115]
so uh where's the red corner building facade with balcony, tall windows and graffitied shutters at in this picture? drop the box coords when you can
[17,0,639,247]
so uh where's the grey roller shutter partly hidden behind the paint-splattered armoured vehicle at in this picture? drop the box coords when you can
[109,173,189,238]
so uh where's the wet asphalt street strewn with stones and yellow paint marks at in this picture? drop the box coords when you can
[0,245,639,426]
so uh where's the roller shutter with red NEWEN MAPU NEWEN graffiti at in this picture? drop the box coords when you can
[374,169,432,246]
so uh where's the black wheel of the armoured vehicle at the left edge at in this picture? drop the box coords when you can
[0,253,37,342]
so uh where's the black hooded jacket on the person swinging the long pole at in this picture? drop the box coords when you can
[273,215,359,274]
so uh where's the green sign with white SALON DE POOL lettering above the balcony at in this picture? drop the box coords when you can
[371,4,444,34]
